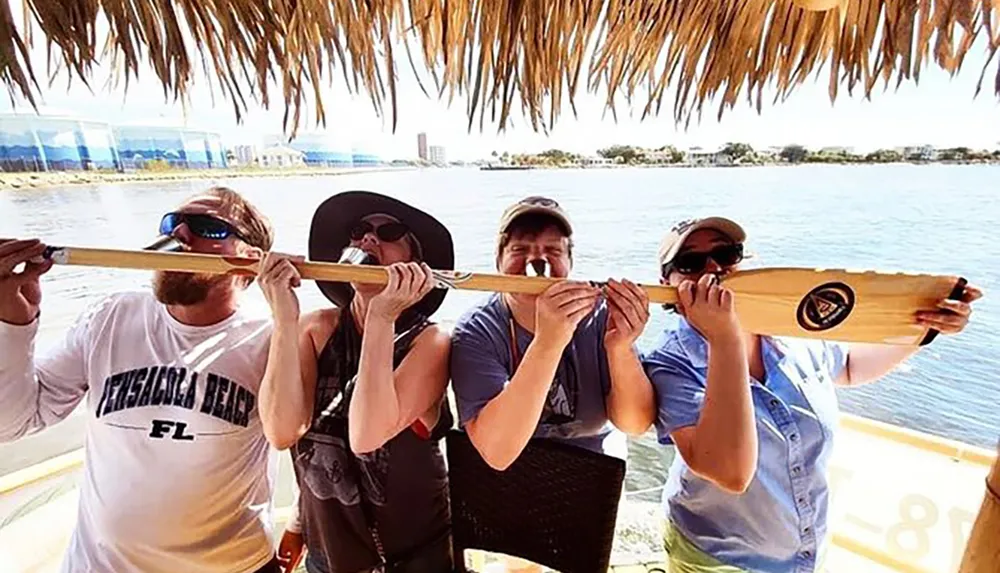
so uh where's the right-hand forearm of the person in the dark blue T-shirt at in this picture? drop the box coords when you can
[607,346,656,436]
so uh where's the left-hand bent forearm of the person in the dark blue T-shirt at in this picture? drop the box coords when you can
[467,337,563,470]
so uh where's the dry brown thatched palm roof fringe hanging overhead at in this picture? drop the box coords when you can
[0,0,1000,135]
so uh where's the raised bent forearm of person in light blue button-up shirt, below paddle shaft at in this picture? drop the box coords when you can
[688,337,757,492]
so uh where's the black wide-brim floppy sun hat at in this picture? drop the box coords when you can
[309,191,455,323]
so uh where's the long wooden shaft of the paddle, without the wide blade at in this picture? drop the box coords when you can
[39,247,677,304]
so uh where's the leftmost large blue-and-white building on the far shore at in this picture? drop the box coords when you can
[0,114,122,171]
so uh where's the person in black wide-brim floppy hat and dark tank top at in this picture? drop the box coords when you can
[260,191,454,573]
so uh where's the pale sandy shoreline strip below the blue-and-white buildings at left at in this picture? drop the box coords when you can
[0,165,416,192]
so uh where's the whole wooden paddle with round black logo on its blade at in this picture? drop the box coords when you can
[46,247,966,345]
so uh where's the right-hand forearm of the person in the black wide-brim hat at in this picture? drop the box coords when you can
[347,311,400,453]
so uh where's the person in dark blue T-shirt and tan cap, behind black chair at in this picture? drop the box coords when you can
[451,196,655,462]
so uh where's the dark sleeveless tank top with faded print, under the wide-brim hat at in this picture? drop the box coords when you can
[292,309,453,573]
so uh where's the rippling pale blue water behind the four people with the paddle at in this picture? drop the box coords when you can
[0,165,1000,497]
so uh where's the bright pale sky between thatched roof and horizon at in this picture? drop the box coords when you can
[0,15,1000,160]
